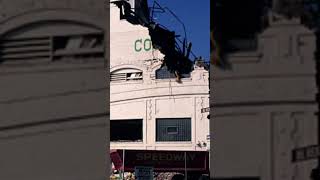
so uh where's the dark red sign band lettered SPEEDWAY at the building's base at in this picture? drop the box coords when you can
[111,150,209,173]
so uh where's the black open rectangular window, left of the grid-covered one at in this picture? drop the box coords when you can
[110,119,143,142]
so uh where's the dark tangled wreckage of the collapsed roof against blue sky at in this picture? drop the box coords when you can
[111,0,199,80]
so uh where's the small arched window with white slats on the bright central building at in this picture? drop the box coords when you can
[110,68,143,82]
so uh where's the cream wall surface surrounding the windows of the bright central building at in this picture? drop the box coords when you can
[110,3,210,151]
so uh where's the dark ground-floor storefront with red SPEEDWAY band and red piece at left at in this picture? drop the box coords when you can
[110,149,209,179]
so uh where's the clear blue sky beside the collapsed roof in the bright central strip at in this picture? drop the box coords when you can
[148,0,210,61]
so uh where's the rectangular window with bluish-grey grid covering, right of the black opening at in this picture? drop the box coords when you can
[156,118,191,142]
